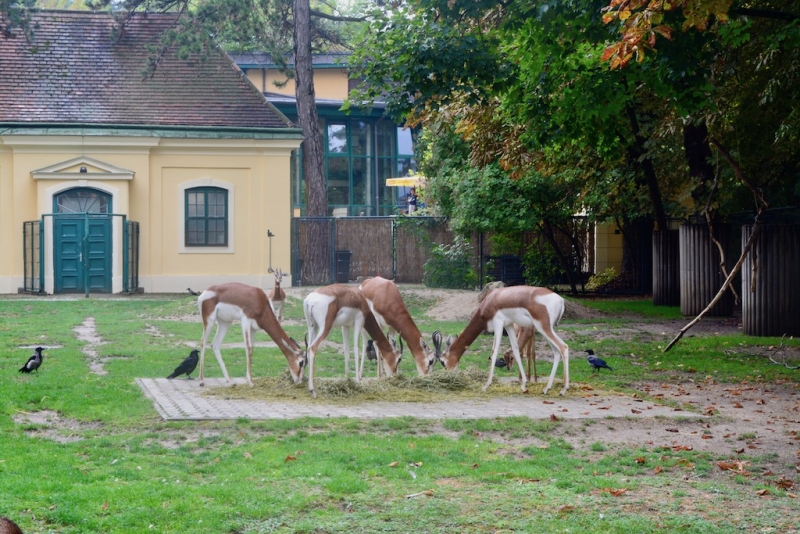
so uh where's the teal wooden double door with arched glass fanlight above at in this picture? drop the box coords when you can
[53,188,112,293]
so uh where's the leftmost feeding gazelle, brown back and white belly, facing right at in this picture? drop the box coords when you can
[197,282,306,386]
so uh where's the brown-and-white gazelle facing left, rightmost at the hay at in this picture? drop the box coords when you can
[437,286,569,395]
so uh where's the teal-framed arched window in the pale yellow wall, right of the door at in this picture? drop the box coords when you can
[186,187,228,247]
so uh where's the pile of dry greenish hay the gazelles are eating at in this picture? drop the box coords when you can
[206,367,572,404]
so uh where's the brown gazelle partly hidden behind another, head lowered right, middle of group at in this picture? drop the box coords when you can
[359,276,436,376]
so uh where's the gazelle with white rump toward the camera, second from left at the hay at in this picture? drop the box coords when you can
[303,284,402,397]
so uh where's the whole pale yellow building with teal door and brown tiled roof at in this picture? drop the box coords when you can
[0,11,302,293]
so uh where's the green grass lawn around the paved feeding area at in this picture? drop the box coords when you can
[0,295,800,534]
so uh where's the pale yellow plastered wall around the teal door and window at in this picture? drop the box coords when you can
[0,136,299,293]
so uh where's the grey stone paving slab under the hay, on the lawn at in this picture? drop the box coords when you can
[141,378,702,421]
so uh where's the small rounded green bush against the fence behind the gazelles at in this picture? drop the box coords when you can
[422,237,478,289]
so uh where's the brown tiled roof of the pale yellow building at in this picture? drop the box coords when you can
[0,11,290,128]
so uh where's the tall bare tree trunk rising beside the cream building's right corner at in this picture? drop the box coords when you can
[292,0,330,284]
